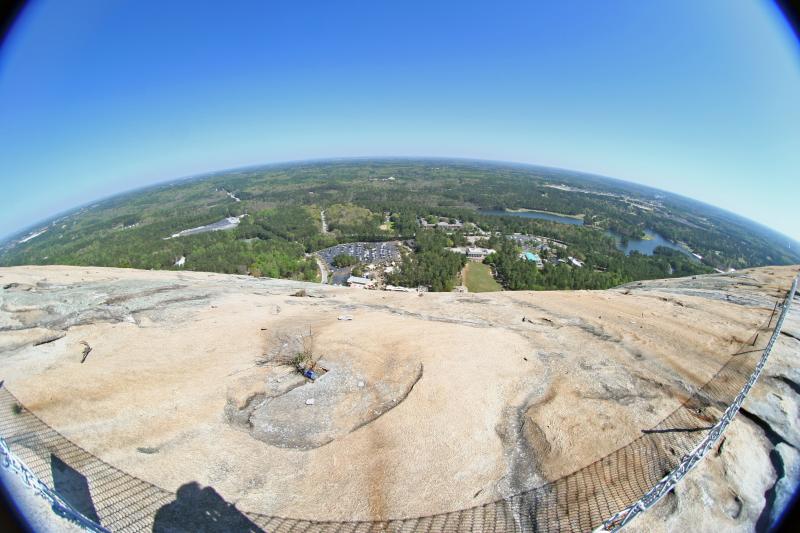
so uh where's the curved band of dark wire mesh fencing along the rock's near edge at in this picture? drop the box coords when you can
[0,278,789,533]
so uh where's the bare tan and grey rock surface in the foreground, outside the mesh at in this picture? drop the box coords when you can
[0,267,800,531]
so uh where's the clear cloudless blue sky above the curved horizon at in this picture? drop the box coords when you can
[0,0,800,239]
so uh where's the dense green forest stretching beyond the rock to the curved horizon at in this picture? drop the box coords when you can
[0,160,788,284]
